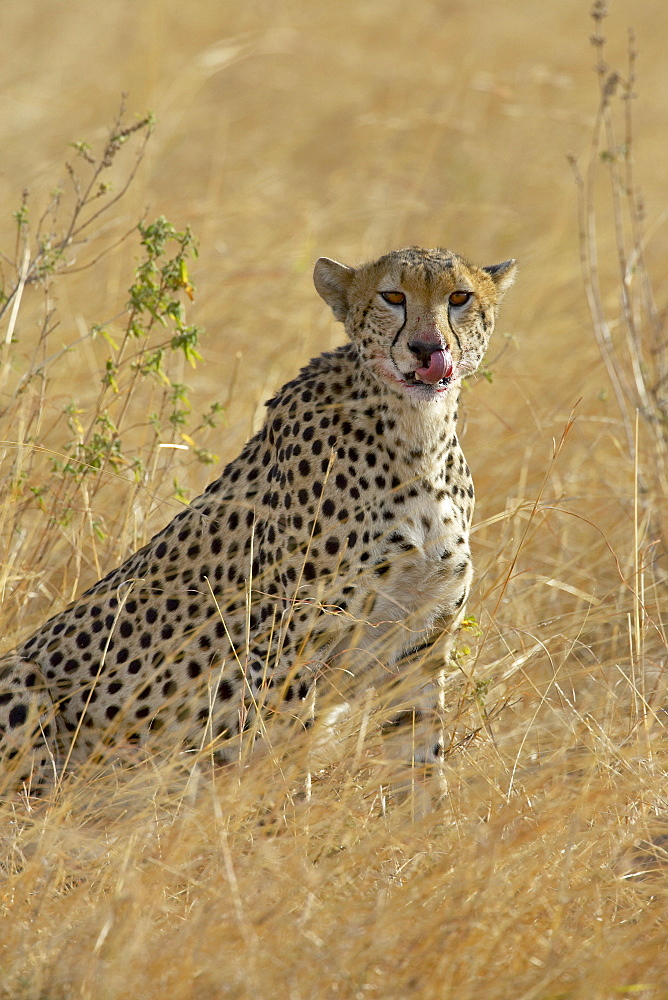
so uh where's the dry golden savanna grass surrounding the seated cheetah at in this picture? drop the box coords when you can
[0,0,668,1000]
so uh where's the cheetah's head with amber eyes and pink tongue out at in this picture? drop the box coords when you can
[313,247,517,401]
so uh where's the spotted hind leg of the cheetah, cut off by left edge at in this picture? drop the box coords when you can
[0,653,56,792]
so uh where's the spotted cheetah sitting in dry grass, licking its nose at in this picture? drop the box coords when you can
[0,247,516,781]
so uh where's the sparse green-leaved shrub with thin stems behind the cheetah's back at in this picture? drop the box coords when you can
[0,106,222,622]
